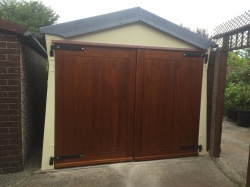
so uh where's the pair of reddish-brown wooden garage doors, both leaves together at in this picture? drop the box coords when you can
[55,46,203,168]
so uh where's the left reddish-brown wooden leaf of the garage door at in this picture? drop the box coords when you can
[55,47,136,168]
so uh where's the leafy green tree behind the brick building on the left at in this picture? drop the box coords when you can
[0,0,59,33]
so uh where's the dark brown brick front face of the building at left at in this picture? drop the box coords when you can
[0,30,24,173]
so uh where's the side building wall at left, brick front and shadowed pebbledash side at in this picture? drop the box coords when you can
[0,29,47,173]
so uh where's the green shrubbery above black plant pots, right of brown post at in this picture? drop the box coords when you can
[224,49,250,110]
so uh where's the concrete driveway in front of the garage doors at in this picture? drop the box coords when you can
[0,121,250,187]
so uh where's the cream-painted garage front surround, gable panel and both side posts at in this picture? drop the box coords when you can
[41,23,207,170]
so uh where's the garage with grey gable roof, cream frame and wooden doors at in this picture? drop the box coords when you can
[41,7,213,169]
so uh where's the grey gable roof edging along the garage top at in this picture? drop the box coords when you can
[40,7,214,49]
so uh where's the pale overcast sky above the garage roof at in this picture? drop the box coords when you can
[40,0,250,35]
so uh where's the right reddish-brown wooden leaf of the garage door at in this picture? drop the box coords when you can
[134,50,203,160]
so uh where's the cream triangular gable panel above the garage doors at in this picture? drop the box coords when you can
[71,23,197,49]
